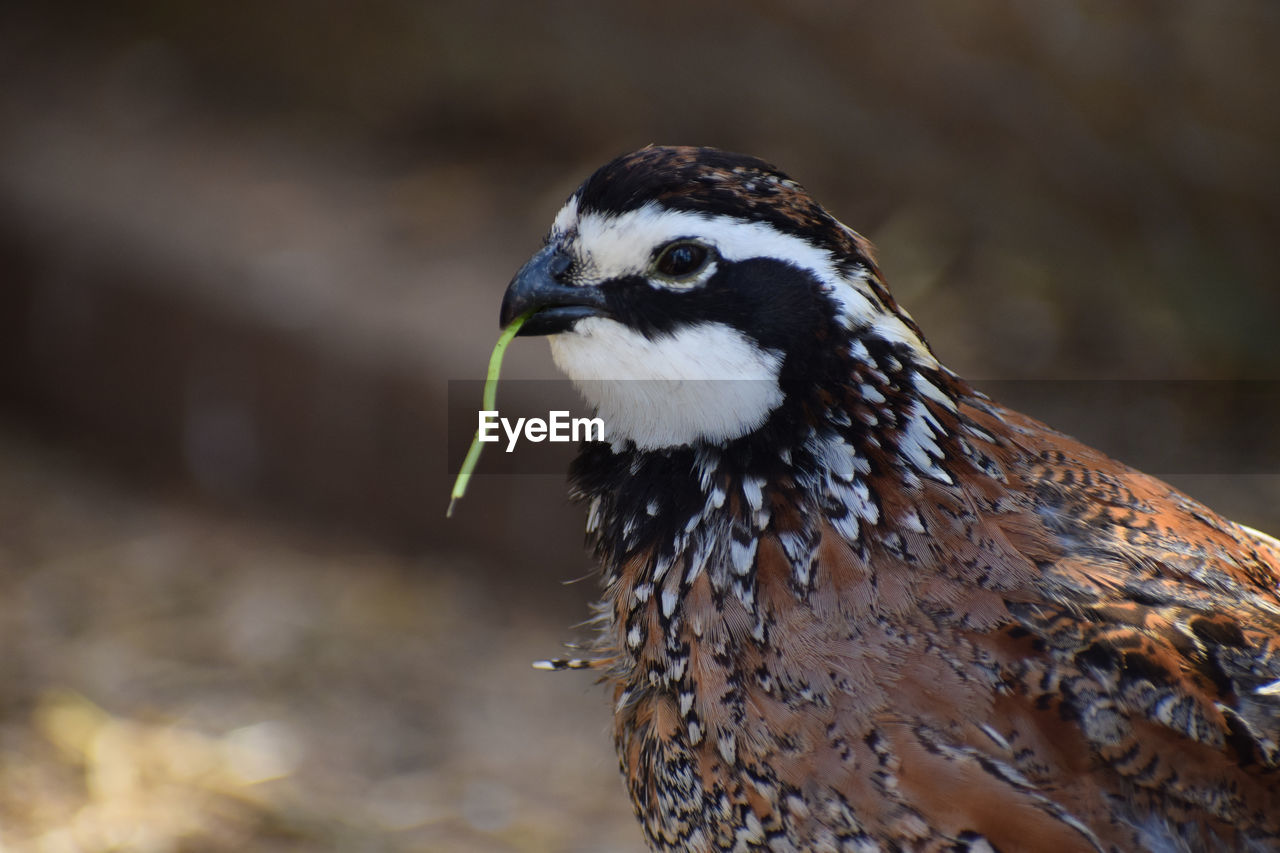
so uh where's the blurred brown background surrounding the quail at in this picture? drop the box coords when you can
[0,0,1280,853]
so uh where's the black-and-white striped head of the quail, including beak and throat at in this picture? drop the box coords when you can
[500,146,936,450]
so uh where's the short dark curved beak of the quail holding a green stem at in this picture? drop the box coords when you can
[498,243,608,337]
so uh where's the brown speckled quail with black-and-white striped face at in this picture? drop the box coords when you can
[500,146,1280,853]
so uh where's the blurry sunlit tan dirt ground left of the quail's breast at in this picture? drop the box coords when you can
[0,432,641,853]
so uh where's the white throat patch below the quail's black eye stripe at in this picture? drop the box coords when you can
[550,318,782,450]
